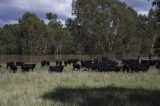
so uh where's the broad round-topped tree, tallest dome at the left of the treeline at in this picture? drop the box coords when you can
[19,12,47,54]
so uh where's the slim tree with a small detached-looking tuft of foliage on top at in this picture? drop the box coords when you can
[46,13,70,59]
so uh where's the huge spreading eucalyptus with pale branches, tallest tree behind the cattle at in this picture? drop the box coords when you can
[72,0,137,55]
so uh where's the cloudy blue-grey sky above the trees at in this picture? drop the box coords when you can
[0,0,151,27]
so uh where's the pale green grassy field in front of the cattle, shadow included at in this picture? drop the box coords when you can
[0,63,160,106]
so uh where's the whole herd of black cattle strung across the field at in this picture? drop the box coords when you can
[0,58,160,73]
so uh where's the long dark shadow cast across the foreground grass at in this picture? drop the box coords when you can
[42,87,160,106]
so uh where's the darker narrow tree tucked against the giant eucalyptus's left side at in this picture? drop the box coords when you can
[65,18,87,54]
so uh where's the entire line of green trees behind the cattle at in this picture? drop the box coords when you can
[0,0,160,55]
